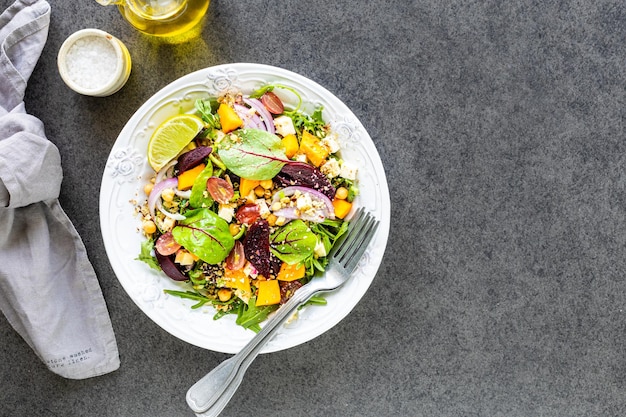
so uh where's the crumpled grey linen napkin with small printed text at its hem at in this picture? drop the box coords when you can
[0,0,120,379]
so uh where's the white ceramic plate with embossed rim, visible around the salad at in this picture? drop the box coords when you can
[100,64,390,353]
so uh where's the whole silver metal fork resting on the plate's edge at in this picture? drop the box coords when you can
[186,207,379,417]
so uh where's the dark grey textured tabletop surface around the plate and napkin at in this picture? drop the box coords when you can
[0,0,626,417]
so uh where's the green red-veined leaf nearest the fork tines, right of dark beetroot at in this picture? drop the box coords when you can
[270,220,317,265]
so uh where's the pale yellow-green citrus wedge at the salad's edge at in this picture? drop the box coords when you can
[148,114,204,172]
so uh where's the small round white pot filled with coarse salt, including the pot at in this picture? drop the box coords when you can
[57,29,131,97]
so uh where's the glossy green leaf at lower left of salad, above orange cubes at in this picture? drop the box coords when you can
[172,208,235,264]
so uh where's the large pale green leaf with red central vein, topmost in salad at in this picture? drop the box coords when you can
[218,129,289,180]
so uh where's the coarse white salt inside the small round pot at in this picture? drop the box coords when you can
[66,36,117,90]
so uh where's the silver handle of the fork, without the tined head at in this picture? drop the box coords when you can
[186,282,323,417]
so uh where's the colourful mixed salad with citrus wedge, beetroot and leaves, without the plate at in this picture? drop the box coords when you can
[137,84,358,332]
